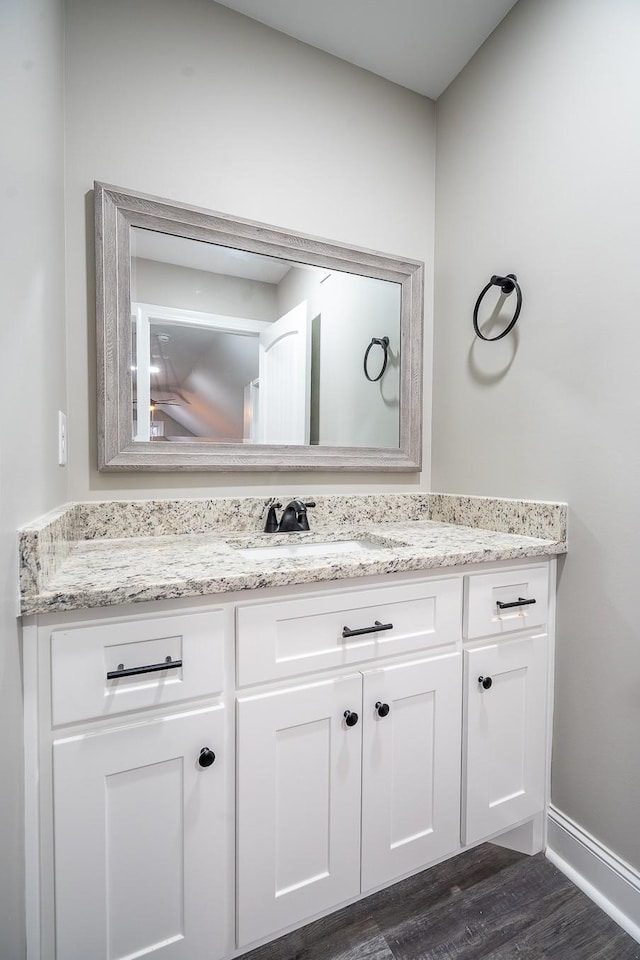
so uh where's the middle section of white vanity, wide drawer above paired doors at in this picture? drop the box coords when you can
[236,576,462,946]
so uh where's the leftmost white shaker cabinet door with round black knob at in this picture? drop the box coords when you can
[53,706,230,960]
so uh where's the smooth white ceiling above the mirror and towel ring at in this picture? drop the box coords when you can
[212,0,516,100]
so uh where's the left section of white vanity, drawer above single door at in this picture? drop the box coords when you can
[25,608,233,960]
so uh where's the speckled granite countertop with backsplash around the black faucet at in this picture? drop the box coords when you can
[20,494,567,615]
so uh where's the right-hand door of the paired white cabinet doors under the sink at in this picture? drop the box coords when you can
[362,653,462,891]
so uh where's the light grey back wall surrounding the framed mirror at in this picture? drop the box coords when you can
[66,0,435,500]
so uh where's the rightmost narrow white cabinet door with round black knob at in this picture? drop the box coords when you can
[463,634,547,843]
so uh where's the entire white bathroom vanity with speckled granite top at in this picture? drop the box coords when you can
[22,495,566,960]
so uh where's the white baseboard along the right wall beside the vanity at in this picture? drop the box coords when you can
[546,804,640,943]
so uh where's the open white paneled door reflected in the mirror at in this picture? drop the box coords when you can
[258,300,311,444]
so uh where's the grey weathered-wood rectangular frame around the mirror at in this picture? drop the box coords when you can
[94,182,424,472]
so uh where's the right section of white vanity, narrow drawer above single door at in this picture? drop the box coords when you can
[462,563,552,844]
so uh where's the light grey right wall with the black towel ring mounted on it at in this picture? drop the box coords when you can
[432,0,640,868]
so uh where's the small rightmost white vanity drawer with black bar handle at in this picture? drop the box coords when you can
[464,563,549,640]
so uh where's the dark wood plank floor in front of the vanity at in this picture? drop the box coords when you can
[243,844,640,960]
